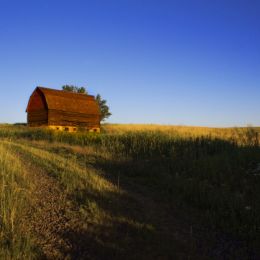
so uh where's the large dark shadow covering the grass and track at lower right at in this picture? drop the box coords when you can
[10,138,260,259]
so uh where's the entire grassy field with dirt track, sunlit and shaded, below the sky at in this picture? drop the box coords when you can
[0,124,260,259]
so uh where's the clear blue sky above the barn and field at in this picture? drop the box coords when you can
[0,0,260,126]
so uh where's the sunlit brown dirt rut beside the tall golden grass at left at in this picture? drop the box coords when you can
[20,156,72,259]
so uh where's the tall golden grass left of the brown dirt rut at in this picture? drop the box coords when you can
[0,143,37,259]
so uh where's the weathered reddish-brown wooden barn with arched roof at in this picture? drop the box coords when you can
[26,87,100,132]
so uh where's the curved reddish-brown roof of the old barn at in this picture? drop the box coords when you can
[27,87,100,114]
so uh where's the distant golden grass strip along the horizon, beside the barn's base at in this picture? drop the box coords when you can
[0,124,260,146]
